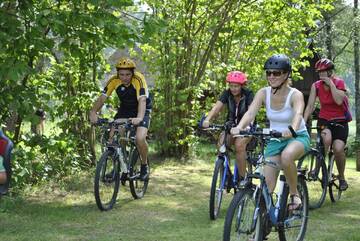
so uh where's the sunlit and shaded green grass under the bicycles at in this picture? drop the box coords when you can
[0,154,360,241]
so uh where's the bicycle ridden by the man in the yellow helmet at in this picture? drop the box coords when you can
[94,119,149,211]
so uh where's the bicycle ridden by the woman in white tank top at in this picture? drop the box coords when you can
[223,129,309,241]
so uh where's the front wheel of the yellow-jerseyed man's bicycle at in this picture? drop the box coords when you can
[94,150,120,211]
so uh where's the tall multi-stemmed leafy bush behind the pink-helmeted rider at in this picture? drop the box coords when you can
[142,0,334,156]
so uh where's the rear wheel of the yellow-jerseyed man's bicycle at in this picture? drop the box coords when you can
[129,147,150,199]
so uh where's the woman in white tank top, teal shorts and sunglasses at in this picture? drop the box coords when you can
[231,54,310,210]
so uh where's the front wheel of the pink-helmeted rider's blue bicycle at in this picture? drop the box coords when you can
[209,157,226,220]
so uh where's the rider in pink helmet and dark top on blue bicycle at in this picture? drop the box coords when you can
[202,71,254,180]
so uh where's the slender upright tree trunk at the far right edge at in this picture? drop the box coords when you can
[354,0,360,171]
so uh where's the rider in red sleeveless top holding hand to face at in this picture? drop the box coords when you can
[304,58,349,191]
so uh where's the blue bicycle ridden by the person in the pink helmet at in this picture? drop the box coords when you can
[200,124,251,220]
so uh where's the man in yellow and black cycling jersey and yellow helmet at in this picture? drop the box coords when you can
[89,58,151,180]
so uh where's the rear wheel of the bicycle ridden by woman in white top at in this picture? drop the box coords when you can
[278,175,309,241]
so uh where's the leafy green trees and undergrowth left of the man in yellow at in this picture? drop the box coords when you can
[0,0,146,185]
